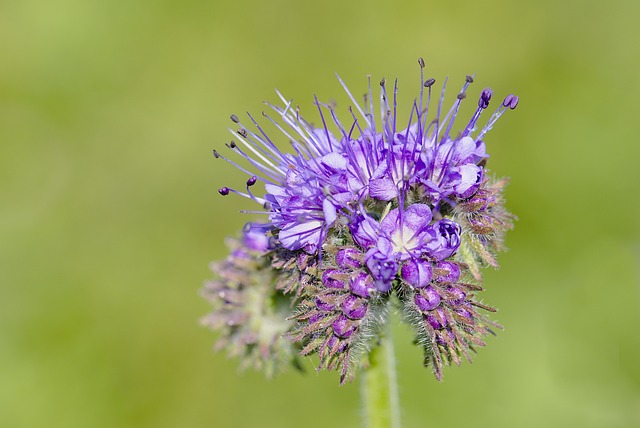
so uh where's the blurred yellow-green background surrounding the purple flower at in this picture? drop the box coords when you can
[0,0,640,428]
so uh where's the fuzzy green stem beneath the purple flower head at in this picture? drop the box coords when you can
[361,326,400,428]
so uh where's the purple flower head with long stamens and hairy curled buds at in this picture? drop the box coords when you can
[205,59,518,382]
